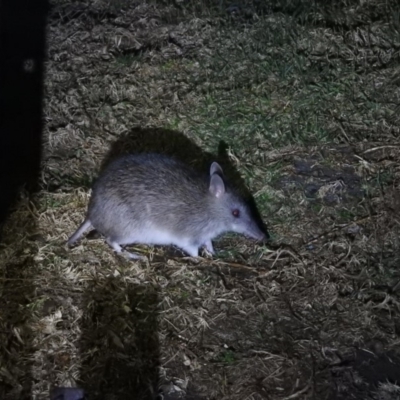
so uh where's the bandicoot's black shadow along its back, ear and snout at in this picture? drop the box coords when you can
[100,128,268,236]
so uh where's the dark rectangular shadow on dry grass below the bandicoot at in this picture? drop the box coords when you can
[78,278,160,400]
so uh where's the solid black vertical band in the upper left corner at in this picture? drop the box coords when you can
[0,0,48,234]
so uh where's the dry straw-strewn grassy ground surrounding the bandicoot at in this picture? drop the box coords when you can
[0,0,400,400]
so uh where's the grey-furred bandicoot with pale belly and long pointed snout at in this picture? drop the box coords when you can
[68,154,265,258]
